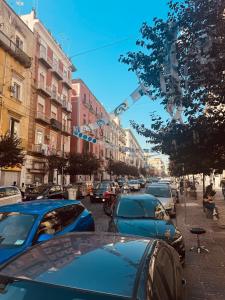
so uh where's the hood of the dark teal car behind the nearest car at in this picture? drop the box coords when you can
[114,218,175,241]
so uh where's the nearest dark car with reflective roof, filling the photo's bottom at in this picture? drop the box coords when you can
[0,233,184,300]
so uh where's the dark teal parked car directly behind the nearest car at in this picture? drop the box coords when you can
[108,194,185,262]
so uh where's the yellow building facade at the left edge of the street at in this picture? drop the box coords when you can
[0,0,34,185]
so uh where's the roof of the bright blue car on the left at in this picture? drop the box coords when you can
[0,199,80,215]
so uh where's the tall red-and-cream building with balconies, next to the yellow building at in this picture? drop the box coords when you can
[21,11,75,184]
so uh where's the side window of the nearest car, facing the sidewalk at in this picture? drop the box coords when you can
[153,247,176,300]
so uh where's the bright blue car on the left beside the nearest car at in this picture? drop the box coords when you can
[0,200,95,264]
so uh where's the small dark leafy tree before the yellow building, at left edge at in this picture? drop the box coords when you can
[0,133,24,168]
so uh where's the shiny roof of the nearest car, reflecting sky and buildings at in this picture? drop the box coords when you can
[0,232,156,297]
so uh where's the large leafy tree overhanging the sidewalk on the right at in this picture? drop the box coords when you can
[120,0,225,174]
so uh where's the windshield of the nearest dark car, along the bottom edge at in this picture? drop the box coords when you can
[0,276,124,300]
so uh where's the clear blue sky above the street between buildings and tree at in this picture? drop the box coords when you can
[8,0,170,148]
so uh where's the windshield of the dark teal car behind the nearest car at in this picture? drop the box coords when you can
[116,198,157,219]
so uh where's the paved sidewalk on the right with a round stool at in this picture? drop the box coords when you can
[177,194,225,300]
